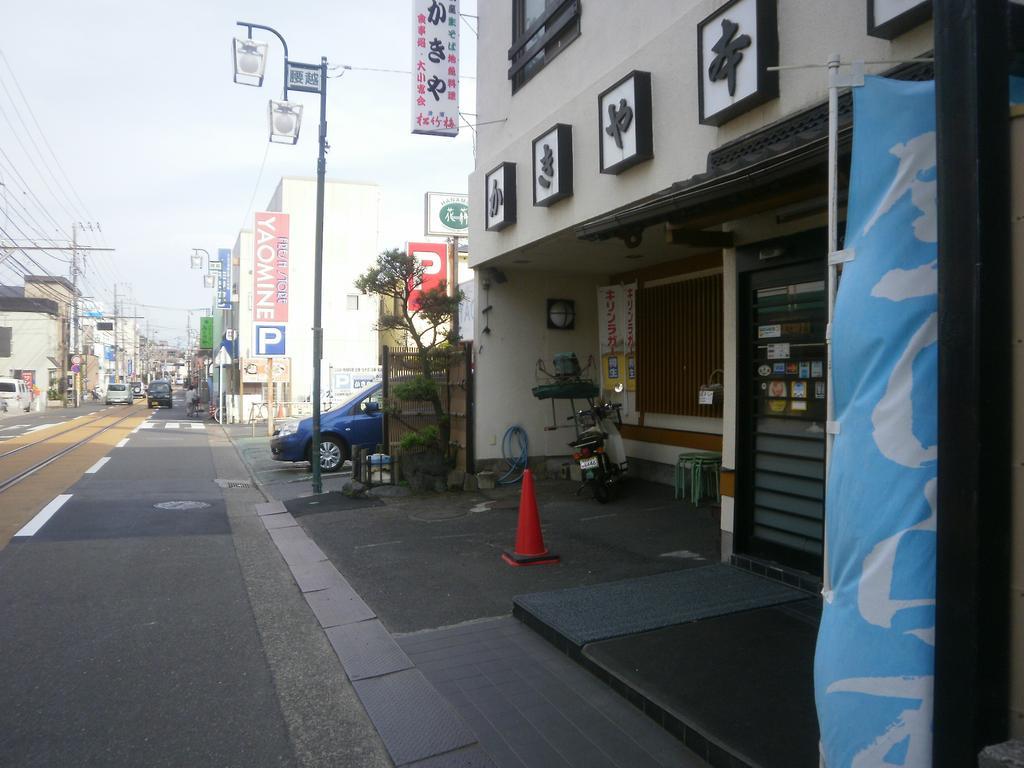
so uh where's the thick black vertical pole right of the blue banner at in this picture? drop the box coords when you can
[933,0,1013,766]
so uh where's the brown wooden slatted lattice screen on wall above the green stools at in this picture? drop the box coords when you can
[636,274,724,418]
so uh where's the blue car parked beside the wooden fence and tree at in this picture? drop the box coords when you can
[270,382,384,472]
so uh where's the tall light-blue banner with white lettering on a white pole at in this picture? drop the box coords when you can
[814,77,938,768]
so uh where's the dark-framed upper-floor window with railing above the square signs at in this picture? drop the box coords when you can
[509,0,580,93]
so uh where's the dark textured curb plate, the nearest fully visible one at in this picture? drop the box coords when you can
[352,669,476,766]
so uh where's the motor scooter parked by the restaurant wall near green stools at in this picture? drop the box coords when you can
[569,402,629,504]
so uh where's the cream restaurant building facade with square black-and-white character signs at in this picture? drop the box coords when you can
[470,0,1024,753]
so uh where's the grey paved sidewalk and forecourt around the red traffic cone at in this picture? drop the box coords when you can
[232,429,816,766]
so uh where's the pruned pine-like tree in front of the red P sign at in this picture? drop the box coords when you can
[355,248,463,460]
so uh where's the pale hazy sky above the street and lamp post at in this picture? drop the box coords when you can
[0,0,476,343]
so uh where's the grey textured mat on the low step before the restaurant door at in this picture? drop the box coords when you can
[512,564,808,648]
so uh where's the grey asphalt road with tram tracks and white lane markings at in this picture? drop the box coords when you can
[0,402,390,767]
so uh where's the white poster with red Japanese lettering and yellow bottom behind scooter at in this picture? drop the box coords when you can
[597,283,637,403]
